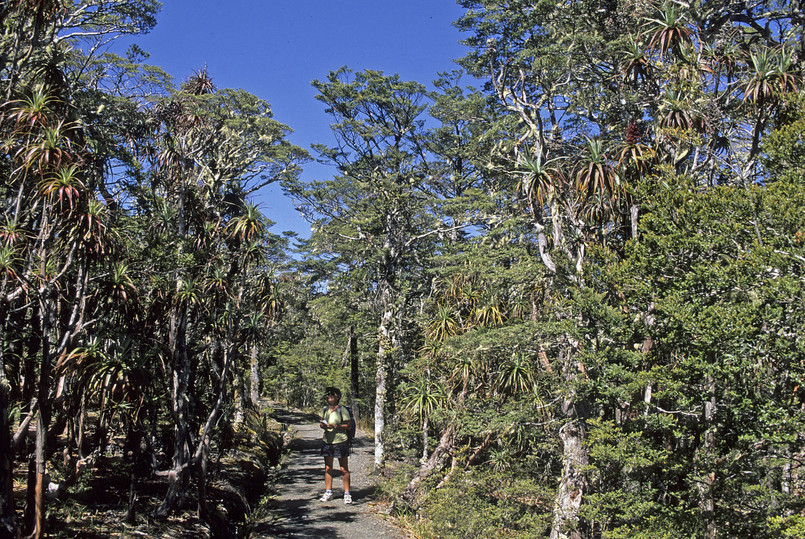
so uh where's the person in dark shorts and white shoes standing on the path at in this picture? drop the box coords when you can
[319,387,352,504]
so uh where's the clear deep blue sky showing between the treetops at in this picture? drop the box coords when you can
[121,0,472,237]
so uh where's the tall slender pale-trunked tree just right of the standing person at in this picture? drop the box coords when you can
[287,69,472,466]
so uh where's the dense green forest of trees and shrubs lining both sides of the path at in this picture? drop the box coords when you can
[0,0,805,539]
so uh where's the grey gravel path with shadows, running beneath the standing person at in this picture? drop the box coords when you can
[255,409,410,539]
